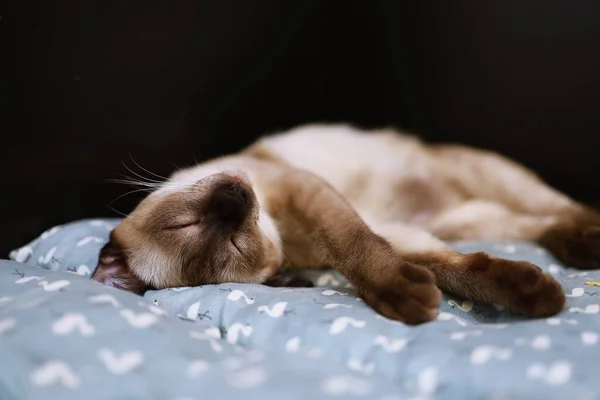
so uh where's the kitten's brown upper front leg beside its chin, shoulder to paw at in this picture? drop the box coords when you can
[269,170,441,324]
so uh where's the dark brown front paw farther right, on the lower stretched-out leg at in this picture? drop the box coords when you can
[488,259,566,317]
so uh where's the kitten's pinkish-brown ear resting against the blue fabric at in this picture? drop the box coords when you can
[92,240,151,295]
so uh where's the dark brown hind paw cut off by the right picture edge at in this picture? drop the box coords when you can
[538,212,600,269]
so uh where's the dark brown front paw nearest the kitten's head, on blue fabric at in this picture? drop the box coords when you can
[359,262,442,325]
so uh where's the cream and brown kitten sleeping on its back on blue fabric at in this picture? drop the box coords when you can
[93,125,600,324]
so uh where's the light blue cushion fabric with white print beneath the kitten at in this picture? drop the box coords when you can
[0,220,600,400]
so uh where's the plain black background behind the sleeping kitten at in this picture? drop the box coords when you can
[0,0,600,256]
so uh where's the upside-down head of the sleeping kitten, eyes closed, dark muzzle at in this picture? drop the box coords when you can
[93,173,282,293]
